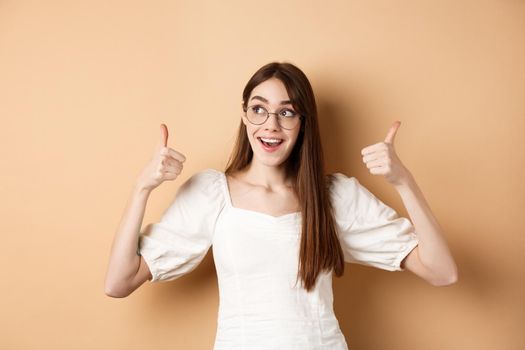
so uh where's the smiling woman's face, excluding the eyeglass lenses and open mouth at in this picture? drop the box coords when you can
[242,78,302,166]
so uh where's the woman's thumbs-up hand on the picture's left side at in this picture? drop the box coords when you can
[137,124,186,191]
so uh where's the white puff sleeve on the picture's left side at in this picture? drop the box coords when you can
[137,169,224,282]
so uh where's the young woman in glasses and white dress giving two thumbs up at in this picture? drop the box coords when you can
[106,62,457,350]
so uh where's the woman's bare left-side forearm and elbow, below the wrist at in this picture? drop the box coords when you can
[105,186,151,298]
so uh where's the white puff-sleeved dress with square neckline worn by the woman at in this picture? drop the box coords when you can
[137,168,418,350]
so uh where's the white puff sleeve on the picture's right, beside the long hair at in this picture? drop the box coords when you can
[330,173,419,271]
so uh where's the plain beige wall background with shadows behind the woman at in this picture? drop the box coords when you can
[0,0,525,350]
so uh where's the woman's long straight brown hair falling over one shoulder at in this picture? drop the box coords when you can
[224,62,344,291]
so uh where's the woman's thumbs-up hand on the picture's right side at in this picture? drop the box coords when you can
[361,121,410,186]
